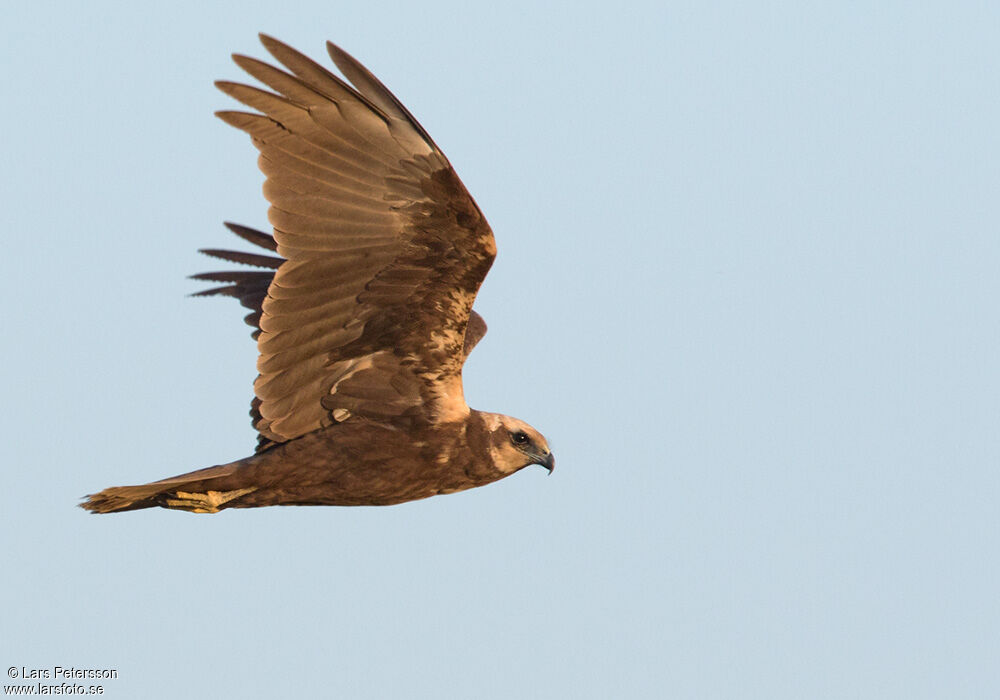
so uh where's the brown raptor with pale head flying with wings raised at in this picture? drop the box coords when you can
[81,35,555,513]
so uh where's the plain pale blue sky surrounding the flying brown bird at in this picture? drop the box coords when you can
[0,0,1000,700]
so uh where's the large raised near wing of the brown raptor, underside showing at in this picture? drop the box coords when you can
[204,35,496,442]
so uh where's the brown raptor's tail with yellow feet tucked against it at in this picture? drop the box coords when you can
[80,462,256,513]
